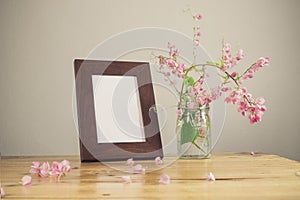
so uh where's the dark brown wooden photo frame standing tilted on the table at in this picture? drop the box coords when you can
[74,59,163,162]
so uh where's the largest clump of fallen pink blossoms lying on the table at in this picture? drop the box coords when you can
[29,160,72,179]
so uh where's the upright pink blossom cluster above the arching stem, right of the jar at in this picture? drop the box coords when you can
[220,43,244,72]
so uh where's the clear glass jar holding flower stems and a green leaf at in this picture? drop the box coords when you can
[177,105,211,158]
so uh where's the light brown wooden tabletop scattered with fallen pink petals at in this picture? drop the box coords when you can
[1,153,300,200]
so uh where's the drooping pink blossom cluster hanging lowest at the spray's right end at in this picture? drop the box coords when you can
[225,88,267,124]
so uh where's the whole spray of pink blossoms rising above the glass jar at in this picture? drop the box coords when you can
[158,11,270,124]
